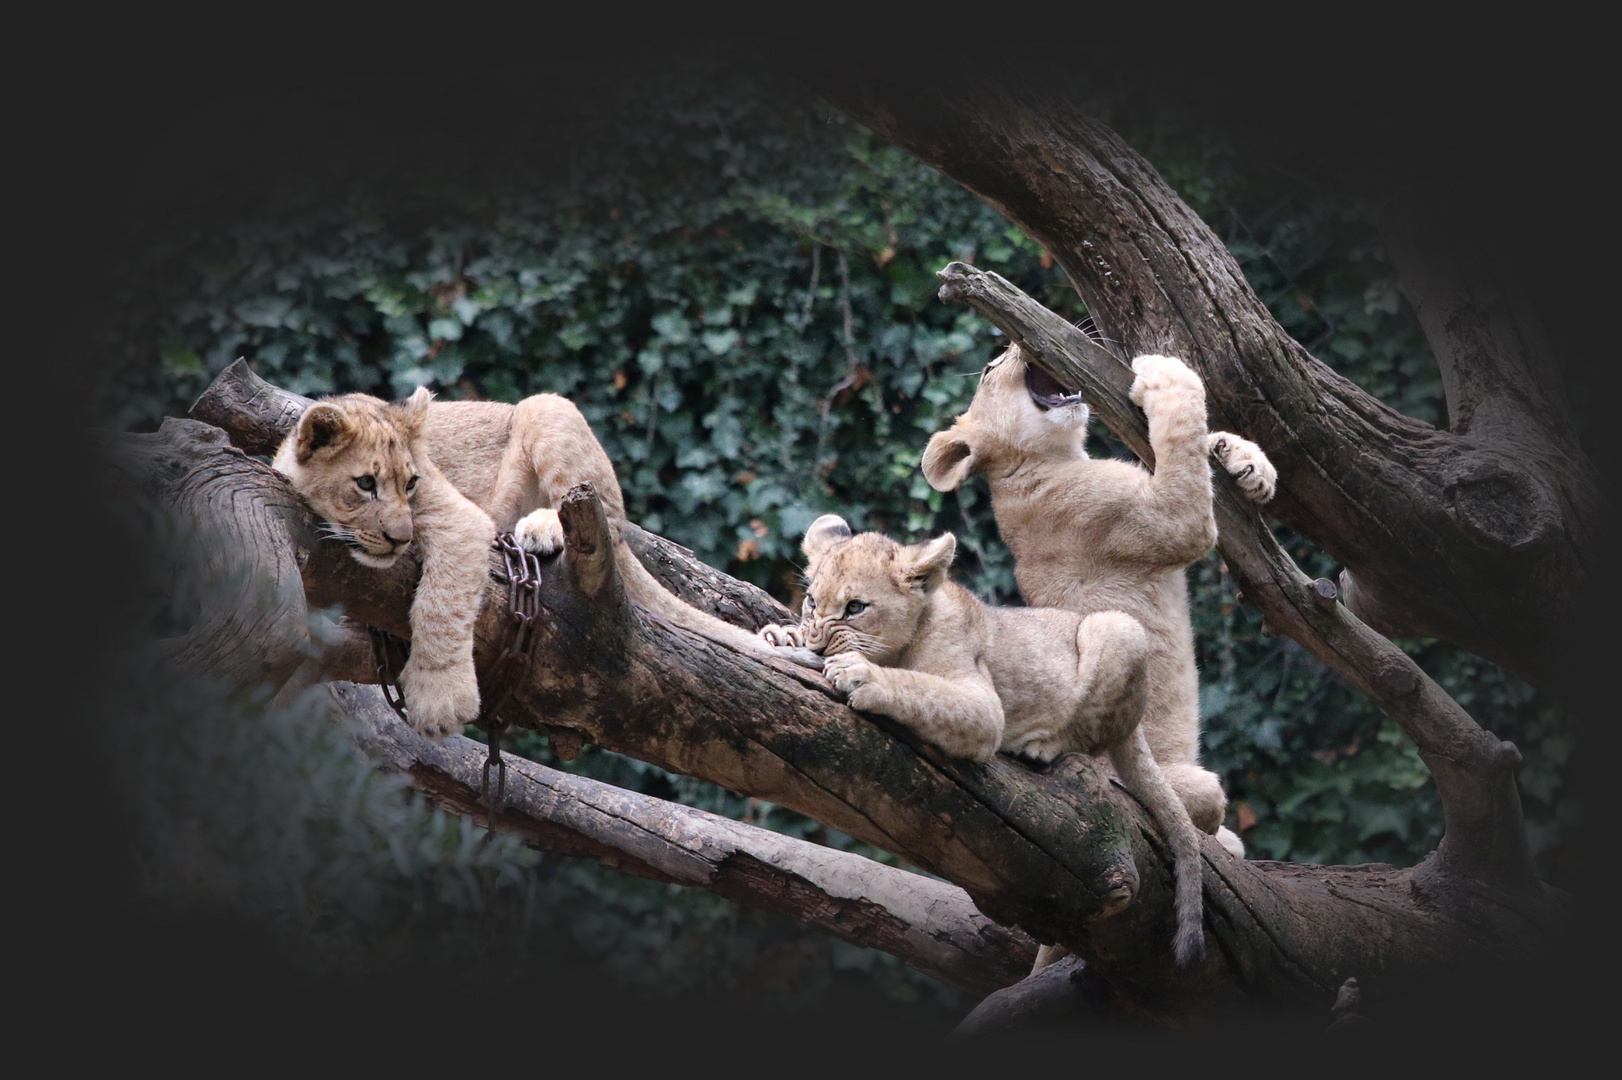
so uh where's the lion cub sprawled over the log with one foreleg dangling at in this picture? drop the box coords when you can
[274,382,807,738]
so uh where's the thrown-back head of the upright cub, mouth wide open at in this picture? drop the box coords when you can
[923,345,1090,491]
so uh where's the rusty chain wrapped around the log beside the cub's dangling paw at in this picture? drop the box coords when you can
[367,532,540,823]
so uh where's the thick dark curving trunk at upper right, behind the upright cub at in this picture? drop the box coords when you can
[806,65,1614,692]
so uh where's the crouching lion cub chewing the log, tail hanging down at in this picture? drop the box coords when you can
[761,514,1205,968]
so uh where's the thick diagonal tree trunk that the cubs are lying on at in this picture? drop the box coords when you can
[107,376,1565,1018]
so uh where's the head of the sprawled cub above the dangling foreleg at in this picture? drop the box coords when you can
[274,389,433,569]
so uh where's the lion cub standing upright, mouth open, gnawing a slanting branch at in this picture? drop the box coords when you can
[923,345,1277,856]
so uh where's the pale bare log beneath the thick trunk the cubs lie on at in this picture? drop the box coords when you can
[333,683,1036,994]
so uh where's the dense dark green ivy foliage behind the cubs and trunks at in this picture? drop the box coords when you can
[104,65,1577,997]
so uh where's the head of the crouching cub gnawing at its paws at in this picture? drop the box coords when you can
[800,514,957,663]
